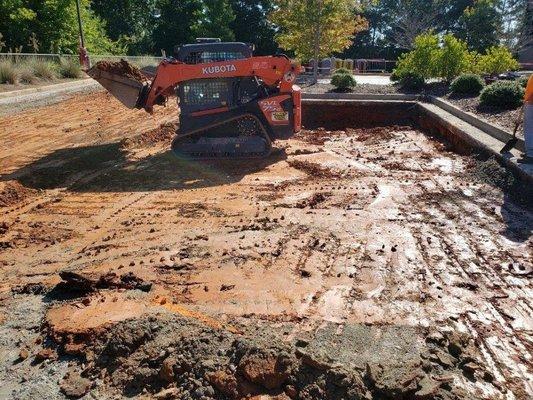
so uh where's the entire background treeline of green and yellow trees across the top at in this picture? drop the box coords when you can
[0,0,531,59]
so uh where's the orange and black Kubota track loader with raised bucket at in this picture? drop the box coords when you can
[88,39,301,158]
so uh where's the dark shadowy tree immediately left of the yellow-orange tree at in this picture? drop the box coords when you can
[230,0,278,55]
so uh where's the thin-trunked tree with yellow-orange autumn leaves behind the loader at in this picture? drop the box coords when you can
[270,0,368,82]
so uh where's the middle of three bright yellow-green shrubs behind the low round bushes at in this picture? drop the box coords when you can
[435,34,470,82]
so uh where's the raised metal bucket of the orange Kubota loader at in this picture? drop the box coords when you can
[87,67,150,108]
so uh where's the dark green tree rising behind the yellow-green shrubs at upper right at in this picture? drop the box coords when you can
[458,0,502,52]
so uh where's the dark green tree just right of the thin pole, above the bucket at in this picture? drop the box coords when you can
[91,0,157,54]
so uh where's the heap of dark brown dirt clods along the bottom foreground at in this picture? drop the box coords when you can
[43,315,493,400]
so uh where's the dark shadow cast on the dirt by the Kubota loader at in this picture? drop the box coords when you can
[0,143,287,192]
